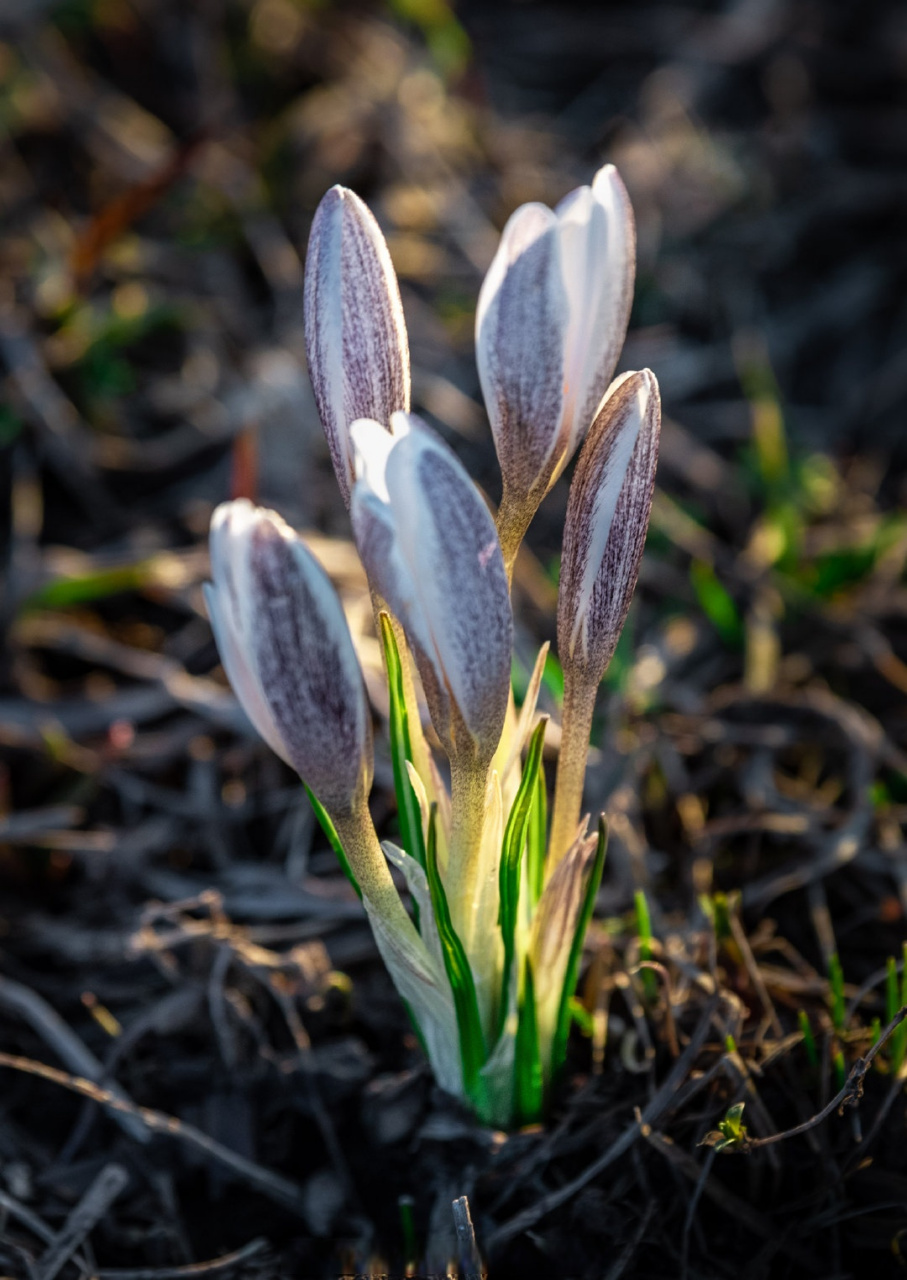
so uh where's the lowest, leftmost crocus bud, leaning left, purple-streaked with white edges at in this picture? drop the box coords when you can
[205,499,372,814]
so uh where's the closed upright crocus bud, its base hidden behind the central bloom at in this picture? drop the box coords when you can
[304,187,409,506]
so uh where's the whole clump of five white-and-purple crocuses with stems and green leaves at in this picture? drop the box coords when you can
[206,166,660,1125]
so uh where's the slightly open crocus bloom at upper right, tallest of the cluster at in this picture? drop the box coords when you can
[476,165,636,537]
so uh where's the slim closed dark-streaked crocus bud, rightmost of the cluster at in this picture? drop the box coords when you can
[558,369,661,686]
